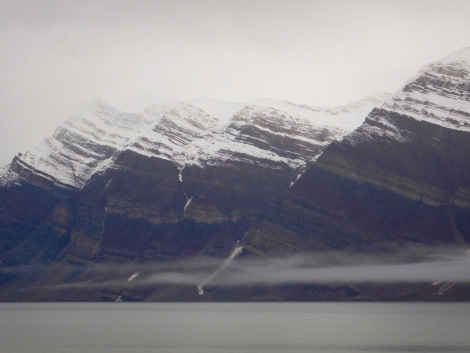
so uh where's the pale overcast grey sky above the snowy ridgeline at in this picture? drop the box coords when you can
[0,0,470,165]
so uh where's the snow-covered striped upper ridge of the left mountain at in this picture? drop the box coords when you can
[2,95,385,188]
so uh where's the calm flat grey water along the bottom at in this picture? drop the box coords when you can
[0,303,470,353]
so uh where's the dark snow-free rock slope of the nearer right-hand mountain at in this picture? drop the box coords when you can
[247,109,470,255]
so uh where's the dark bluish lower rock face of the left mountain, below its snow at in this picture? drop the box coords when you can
[0,147,292,300]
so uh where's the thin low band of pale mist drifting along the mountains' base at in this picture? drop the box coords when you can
[0,248,470,287]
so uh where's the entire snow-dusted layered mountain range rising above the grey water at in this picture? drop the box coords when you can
[0,48,470,301]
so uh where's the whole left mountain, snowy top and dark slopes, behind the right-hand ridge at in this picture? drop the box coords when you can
[0,94,384,300]
